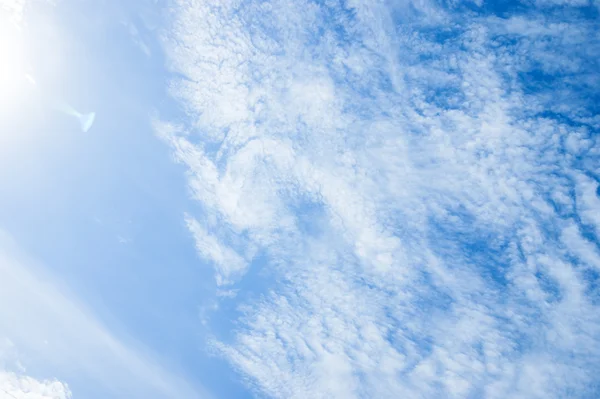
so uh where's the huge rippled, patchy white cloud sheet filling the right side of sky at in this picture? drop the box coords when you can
[157,0,600,398]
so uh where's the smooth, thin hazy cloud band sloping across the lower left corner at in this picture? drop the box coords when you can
[0,233,210,398]
